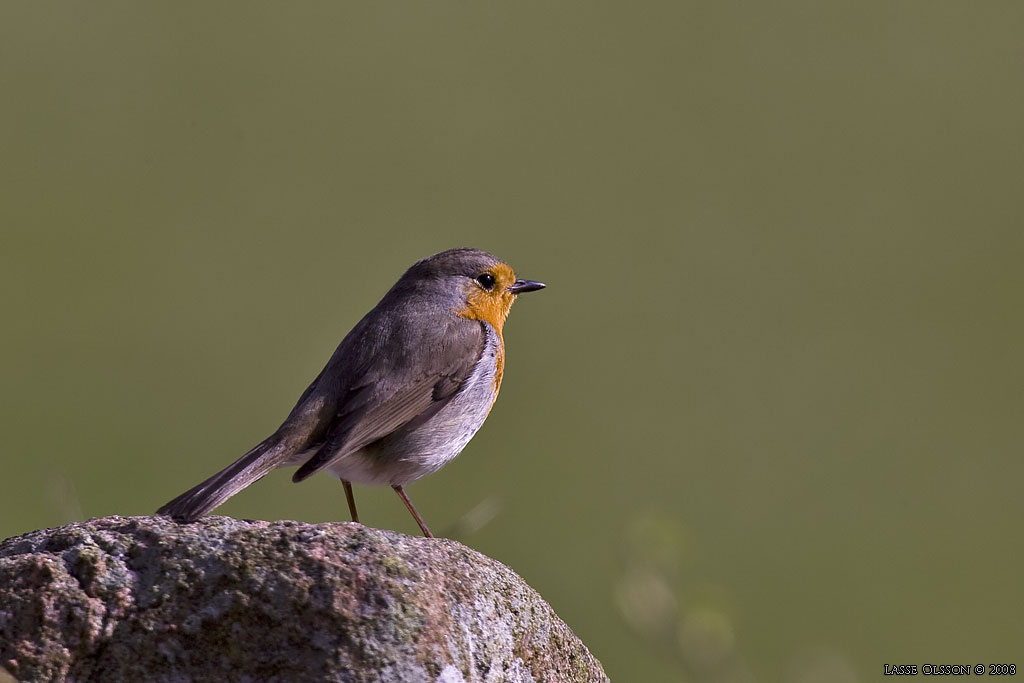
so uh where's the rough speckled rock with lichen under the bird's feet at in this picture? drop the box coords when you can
[0,517,607,683]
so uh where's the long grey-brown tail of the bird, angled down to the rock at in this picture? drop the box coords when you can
[157,434,294,522]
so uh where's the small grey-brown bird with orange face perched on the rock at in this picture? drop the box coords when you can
[157,248,546,538]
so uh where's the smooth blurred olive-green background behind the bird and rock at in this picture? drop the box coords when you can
[0,1,1024,681]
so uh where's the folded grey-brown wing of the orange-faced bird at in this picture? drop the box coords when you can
[292,315,484,481]
